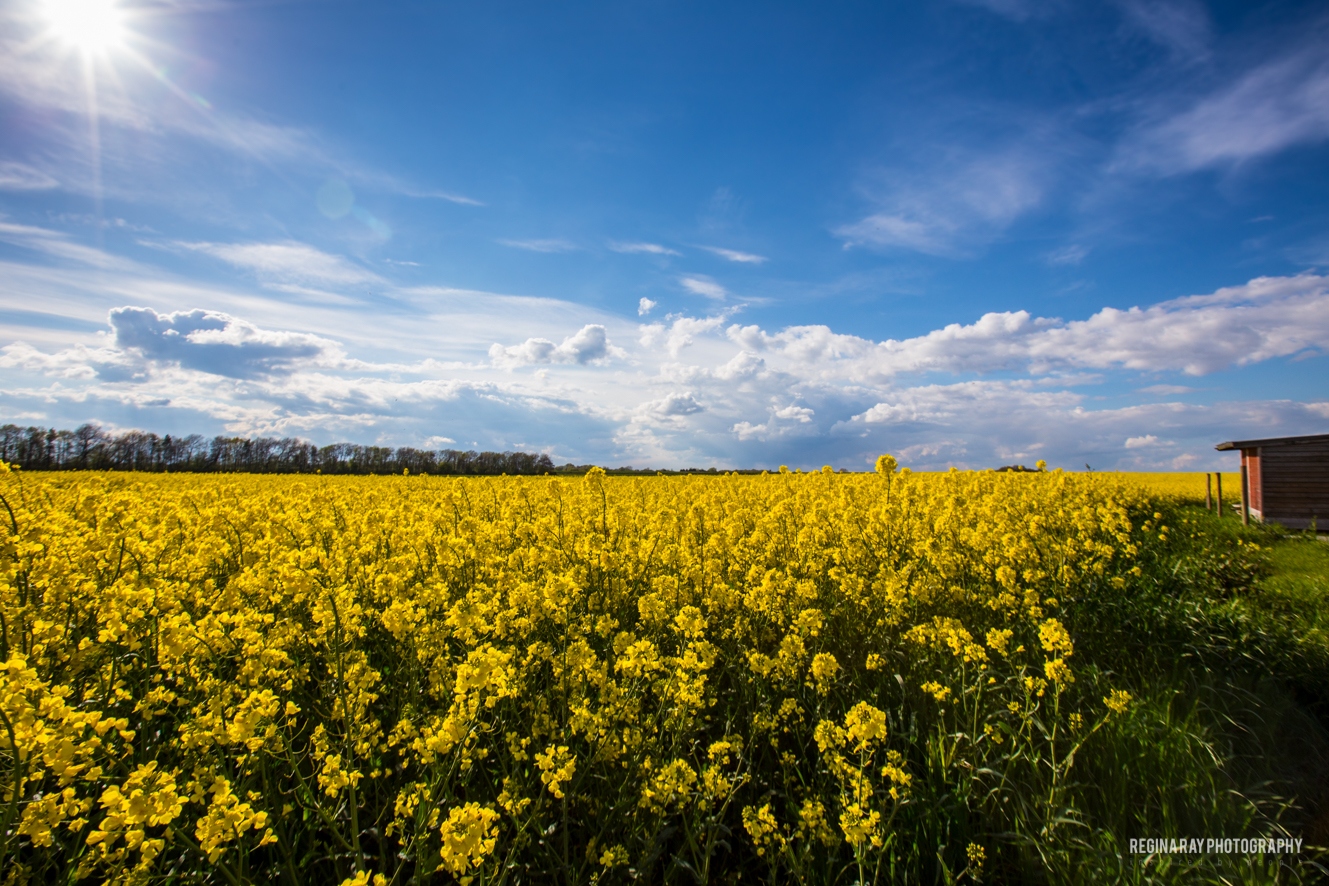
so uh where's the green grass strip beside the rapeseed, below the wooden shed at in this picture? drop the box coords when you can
[1041,506,1329,883]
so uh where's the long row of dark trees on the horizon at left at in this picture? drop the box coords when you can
[0,424,558,476]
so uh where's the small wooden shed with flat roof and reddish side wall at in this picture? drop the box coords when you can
[1215,434,1329,533]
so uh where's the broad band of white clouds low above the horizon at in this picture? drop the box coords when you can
[0,255,1329,470]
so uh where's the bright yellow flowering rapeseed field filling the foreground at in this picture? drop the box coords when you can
[0,457,1203,885]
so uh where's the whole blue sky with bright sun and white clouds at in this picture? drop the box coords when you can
[0,0,1329,470]
